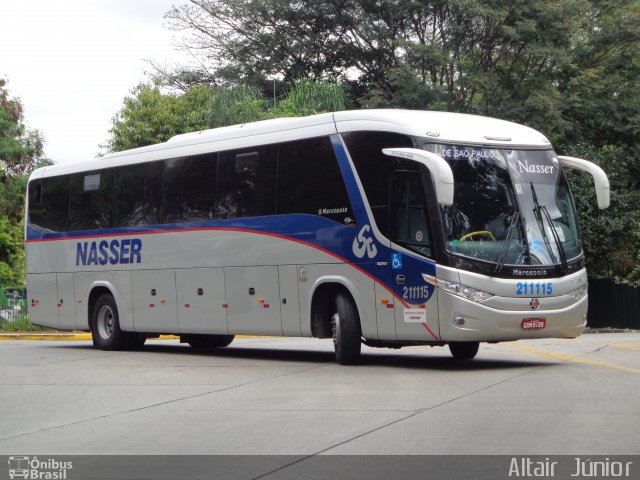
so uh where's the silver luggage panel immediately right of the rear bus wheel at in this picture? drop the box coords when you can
[131,269,179,333]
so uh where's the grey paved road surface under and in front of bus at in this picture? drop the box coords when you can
[0,333,640,455]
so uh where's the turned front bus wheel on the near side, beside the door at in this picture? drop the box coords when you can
[331,292,362,365]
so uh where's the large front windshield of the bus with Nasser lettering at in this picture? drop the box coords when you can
[425,144,582,269]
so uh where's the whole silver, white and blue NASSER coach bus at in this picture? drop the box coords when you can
[25,109,609,364]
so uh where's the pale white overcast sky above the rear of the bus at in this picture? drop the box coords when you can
[0,0,186,163]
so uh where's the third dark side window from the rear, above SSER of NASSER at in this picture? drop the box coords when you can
[114,162,164,227]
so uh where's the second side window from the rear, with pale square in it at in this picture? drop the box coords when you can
[69,170,113,230]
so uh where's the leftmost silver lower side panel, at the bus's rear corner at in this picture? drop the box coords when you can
[27,273,60,328]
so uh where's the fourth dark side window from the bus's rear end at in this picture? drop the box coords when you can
[162,153,217,223]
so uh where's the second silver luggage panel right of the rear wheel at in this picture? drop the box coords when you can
[176,268,228,335]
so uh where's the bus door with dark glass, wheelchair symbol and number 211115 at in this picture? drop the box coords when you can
[388,170,439,341]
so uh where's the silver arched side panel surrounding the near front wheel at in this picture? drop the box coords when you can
[298,263,378,339]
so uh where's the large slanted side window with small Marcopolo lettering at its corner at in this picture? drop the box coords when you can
[277,137,355,225]
